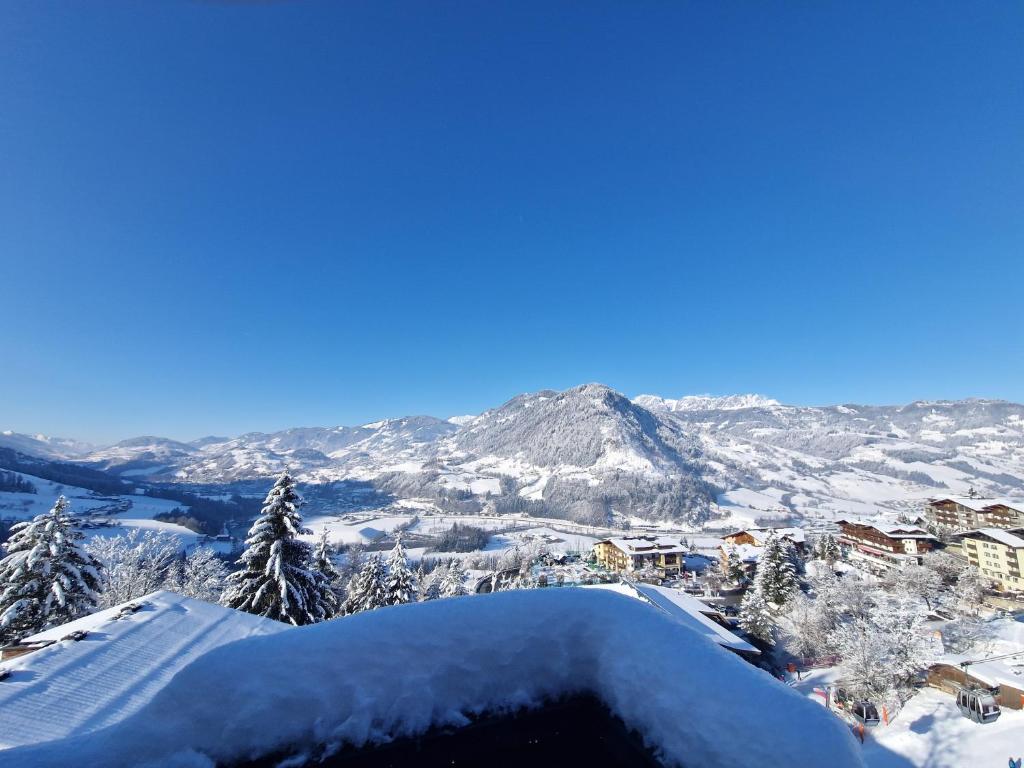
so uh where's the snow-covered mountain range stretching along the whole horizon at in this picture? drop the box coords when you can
[6,384,1024,522]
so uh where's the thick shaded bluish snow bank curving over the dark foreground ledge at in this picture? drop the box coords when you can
[3,588,863,768]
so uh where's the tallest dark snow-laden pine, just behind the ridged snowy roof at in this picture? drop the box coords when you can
[223,472,338,626]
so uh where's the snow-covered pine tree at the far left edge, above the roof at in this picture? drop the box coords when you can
[0,496,102,642]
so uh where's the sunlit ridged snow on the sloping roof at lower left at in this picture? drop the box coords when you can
[0,591,289,763]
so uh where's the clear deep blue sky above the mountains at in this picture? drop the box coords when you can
[0,0,1024,440]
